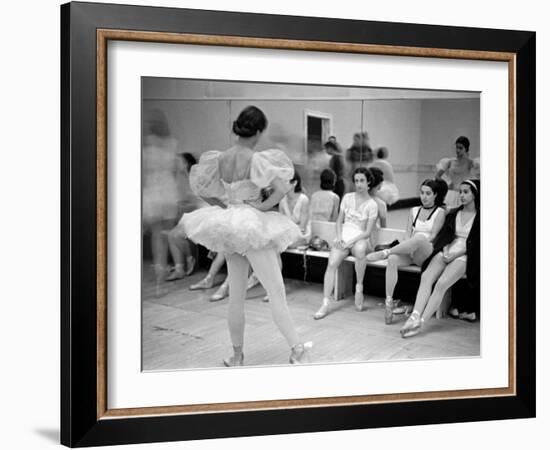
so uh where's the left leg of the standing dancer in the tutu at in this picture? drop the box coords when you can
[226,253,248,351]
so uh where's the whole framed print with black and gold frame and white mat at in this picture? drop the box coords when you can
[61,3,535,446]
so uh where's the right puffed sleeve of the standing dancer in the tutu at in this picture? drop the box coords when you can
[250,149,294,188]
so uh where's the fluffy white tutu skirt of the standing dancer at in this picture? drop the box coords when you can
[180,204,301,255]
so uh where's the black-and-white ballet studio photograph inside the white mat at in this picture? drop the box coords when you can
[141,77,484,372]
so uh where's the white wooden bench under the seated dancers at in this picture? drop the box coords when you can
[285,220,452,318]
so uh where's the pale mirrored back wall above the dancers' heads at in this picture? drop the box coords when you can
[143,78,480,199]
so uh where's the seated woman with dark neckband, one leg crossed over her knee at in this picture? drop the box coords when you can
[367,180,447,325]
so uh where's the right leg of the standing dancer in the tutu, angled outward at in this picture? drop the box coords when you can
[248,249,300,348]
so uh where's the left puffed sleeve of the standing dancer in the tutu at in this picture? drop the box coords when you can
[189,150,225,198]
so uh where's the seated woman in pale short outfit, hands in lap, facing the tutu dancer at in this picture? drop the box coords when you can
[313,167,382,320]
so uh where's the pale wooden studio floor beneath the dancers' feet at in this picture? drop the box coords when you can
[142,266,480,371]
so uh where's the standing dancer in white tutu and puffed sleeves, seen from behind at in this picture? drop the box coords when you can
[184,106,306,367]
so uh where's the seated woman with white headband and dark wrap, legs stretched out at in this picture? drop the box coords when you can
[401,180,481,338]
